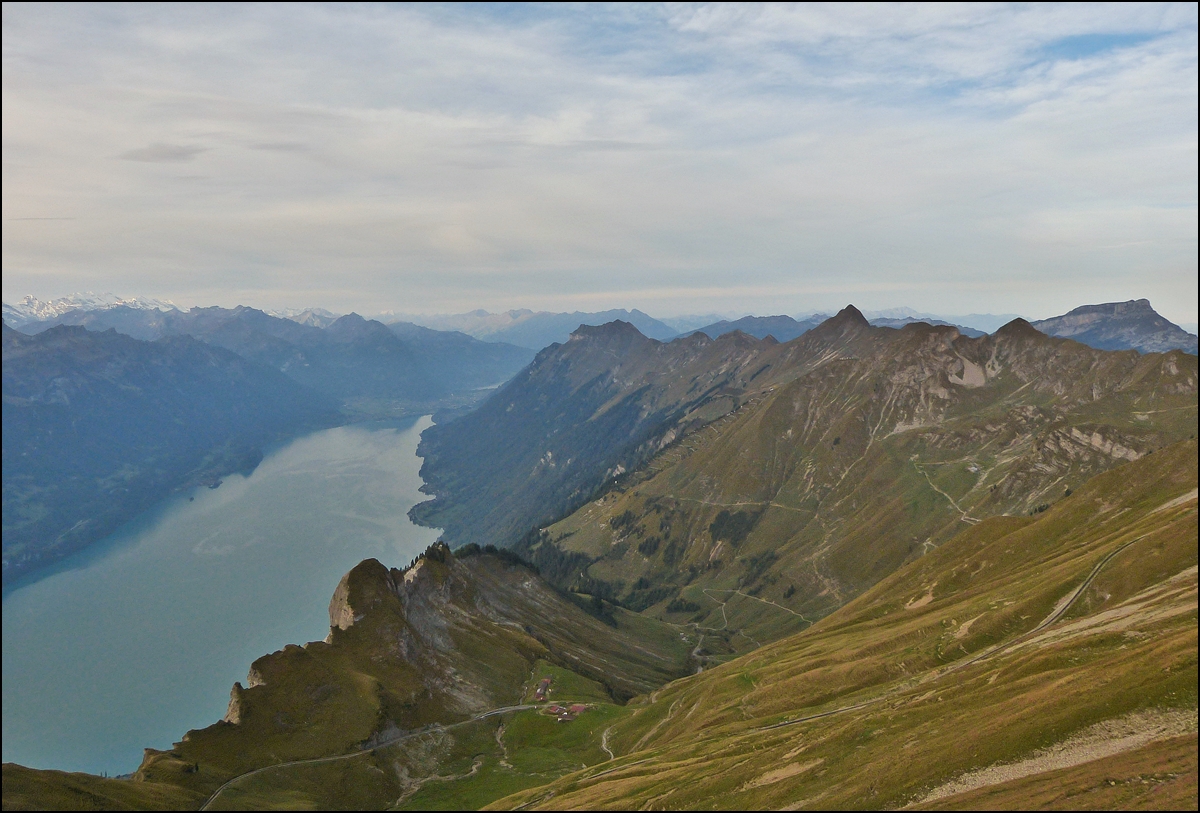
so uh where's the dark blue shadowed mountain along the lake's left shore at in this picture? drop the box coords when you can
[4,325,342,584]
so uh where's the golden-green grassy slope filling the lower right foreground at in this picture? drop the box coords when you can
[496,440,1196,809]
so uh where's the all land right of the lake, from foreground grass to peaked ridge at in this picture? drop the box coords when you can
[5,308,1198,809]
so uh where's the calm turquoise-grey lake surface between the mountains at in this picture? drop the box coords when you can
[2,417,439,775]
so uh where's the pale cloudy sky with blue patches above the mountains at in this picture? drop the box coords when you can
[2,2,1198,323]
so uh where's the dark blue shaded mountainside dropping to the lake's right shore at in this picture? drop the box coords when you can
[412,321,777,544]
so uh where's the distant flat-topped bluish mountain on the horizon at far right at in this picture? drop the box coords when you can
[1033,300,1198,355]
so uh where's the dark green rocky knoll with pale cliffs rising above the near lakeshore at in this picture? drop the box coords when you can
[4,547,689,808]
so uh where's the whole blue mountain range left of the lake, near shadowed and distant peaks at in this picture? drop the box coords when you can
[4,302,533,585]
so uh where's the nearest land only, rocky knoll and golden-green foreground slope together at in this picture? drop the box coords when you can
[5,440,1196,809]
